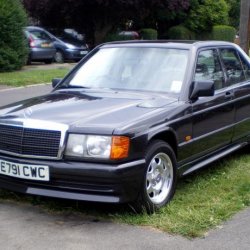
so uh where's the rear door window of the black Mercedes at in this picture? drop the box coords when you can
[220,49,245,85]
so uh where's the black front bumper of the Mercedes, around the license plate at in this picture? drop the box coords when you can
[0,155,145,203]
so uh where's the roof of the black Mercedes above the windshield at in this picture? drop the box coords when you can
[101,40,235,49]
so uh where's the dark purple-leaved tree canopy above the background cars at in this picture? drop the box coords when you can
[23,0,189,43]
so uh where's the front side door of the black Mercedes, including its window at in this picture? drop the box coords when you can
[189,49,234,158]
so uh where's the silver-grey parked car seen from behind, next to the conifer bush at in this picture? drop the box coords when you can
[24,27,56,64]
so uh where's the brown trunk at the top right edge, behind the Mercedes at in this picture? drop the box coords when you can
[239,0,250,54]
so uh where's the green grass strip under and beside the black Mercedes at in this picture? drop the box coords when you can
[0,148,250,237]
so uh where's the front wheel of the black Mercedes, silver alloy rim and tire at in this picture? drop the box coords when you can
[132,140,177,214]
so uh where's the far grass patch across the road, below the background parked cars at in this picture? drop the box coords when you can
[0,68,69,87]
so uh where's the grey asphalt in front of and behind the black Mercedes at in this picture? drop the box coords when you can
[0,85,250,250]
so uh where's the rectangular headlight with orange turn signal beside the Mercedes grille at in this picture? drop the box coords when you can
[65,134,130,159]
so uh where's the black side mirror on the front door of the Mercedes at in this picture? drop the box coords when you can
[190,80,214,100]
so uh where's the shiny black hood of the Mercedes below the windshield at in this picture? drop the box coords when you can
[0,89,177,133]
